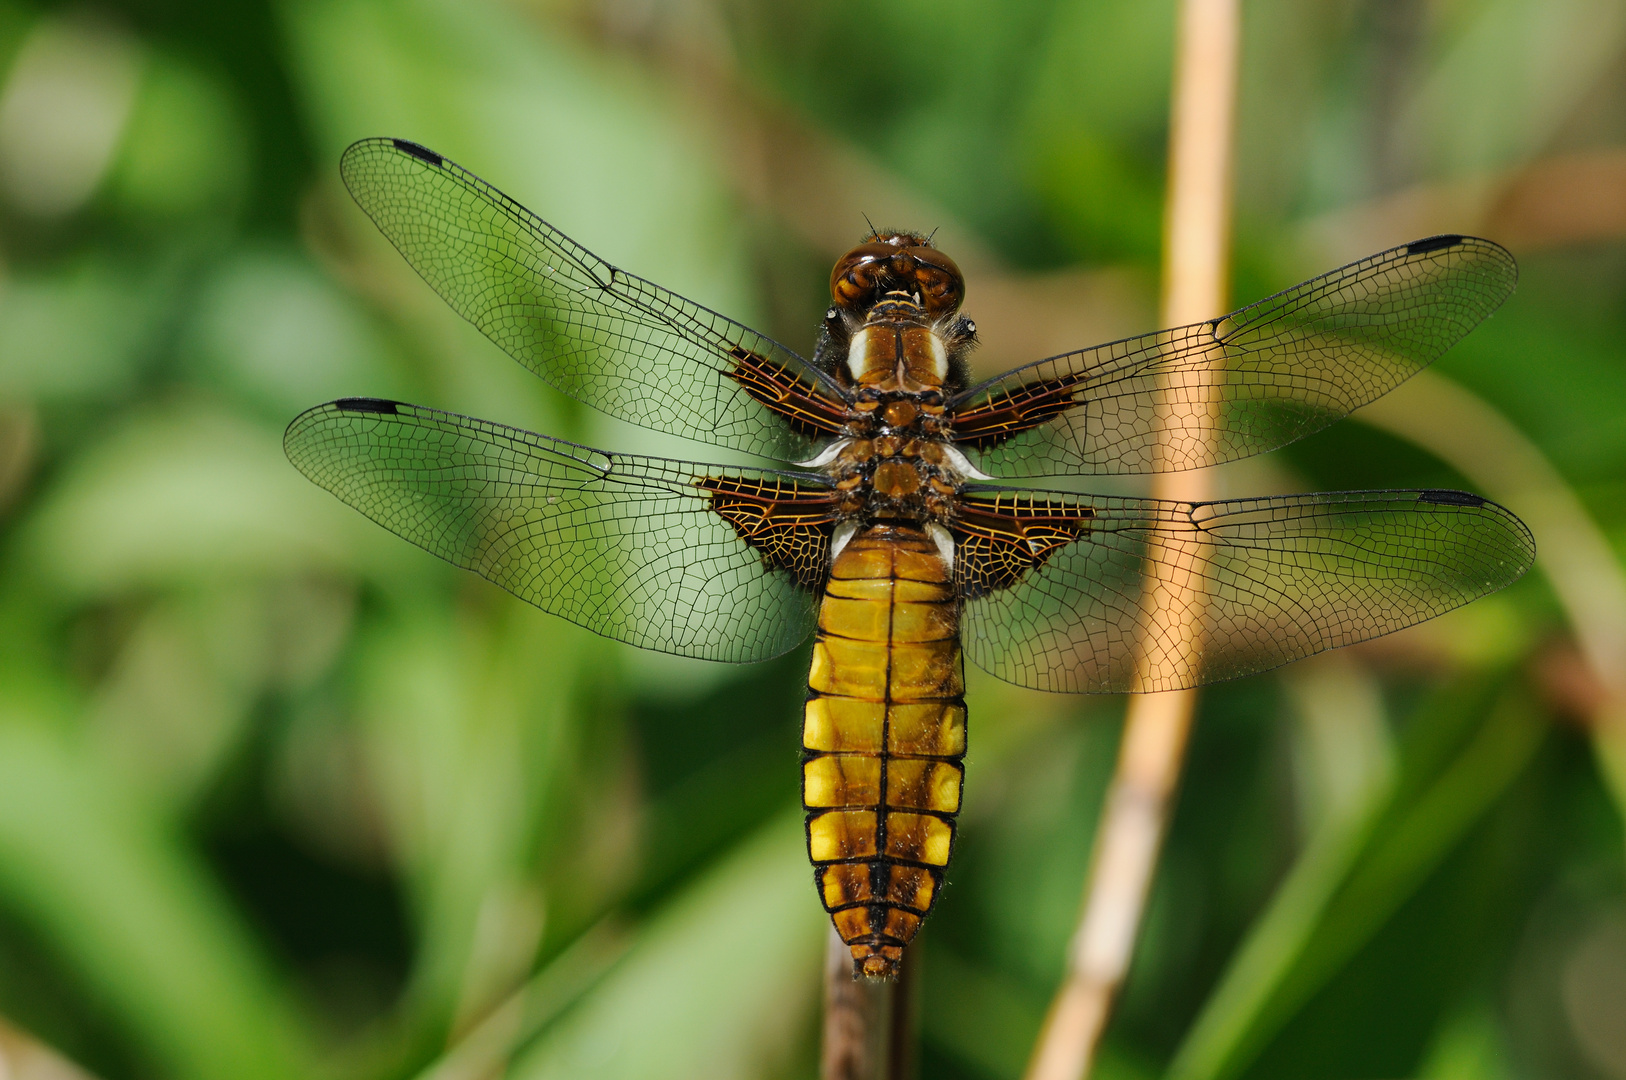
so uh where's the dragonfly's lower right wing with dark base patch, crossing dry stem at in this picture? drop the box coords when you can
[954,490,1535,693]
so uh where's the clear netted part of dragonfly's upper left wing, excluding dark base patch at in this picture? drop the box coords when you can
[340,138,841,460]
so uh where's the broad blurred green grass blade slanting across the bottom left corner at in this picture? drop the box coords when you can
[0,716,312,1080]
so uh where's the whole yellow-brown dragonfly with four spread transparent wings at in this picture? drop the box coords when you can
[285,138,1535,978]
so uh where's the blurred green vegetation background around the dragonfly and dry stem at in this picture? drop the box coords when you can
[0,0,1626,1080]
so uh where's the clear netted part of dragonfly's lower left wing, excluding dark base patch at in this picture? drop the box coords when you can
[283,398,826,662]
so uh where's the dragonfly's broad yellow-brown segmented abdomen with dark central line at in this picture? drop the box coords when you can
[802,525,966,976]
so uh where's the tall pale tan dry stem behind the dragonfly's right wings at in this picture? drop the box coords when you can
[1028,0,1241,1080]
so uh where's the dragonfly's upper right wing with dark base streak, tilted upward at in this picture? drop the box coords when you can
[950,236,1519,477]
